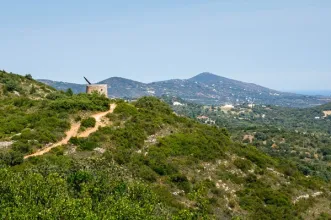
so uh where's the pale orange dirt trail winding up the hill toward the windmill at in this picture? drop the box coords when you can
[24,104,116,159]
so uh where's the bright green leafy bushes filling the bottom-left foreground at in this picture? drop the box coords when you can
[0,157,182,219]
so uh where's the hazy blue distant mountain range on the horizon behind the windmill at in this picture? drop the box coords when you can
[42,73,331,107]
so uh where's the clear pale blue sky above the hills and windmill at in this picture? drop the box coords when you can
[0,0,331,91]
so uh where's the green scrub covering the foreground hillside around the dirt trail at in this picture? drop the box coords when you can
[0,72,331,219]
